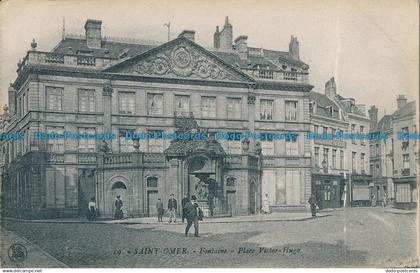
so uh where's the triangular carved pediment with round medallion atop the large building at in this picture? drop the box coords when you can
[106,37,250,81]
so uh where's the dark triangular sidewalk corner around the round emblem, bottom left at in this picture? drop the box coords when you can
[0,228,68,268]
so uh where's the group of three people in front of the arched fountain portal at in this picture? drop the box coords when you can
[156,194,203,237]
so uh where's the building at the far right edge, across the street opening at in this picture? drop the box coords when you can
[369,95,420,208]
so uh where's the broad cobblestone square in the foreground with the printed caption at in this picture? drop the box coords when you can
[2,208,418,267]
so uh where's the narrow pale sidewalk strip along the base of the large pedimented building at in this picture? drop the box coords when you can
[3,212,330,225]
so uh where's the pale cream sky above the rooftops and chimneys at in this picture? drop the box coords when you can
[0,0,419,118]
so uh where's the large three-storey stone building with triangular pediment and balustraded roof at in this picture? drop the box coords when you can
[1,18,312,218]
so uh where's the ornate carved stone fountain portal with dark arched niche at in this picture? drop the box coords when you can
[164,113,226,215]
